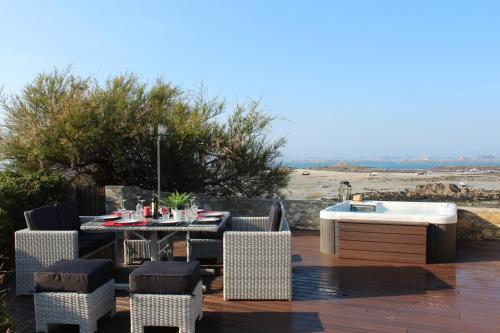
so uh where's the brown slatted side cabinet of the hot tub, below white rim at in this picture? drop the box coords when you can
[320,200,456,264]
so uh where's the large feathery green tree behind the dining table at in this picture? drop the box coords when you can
[0,70,289,197]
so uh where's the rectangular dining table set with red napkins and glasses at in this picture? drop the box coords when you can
[80,211,231,261]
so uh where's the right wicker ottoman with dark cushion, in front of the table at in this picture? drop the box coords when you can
[129,261,203,333]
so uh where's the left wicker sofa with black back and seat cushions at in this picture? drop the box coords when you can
[15,201,116,295]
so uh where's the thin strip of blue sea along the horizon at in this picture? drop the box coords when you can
[283,160,500,170]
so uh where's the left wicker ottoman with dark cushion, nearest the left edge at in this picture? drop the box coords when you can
[34,259,116,333]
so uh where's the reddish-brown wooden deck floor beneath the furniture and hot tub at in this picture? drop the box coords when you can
[8,231,500,333]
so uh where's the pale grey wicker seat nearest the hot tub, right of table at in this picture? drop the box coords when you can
[224,203,292,300]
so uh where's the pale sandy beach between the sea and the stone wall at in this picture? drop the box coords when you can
[284,169,500,199]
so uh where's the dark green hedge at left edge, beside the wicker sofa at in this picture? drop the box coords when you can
[0,170,71,265]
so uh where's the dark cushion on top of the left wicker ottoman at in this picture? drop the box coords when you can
[34,259,113,293]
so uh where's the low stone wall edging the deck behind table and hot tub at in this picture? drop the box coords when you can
[106,186,500,240]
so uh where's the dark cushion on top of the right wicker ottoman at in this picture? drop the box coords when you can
[129,261,200,294]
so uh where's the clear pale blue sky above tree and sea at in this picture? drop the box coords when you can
[0,0,500,159]
